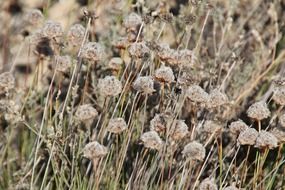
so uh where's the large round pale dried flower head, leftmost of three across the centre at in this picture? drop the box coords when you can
[98,76,122,96]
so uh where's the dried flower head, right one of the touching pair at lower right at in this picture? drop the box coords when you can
[255,130,278,149]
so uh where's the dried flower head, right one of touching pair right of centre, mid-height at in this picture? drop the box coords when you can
[207,89,229,108]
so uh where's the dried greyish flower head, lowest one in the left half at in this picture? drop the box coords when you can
[83,141,108,160]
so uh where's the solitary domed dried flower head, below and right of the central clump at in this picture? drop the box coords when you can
[182,141,206,161]
